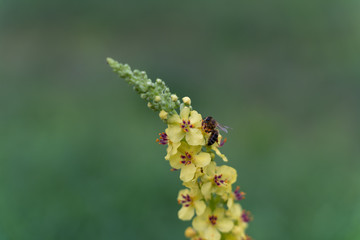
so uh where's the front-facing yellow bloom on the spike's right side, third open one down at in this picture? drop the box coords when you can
[201,165,237,199]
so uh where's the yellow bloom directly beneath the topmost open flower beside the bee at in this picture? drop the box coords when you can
[169,142,211,182]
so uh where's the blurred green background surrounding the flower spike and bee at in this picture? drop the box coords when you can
[0,0,360,240]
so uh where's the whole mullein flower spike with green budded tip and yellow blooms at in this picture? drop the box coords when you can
[107,58,252,240]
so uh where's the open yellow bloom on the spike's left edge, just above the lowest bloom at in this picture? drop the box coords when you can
[178,187,206,220]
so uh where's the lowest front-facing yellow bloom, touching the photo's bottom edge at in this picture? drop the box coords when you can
[192,208,234,240]
